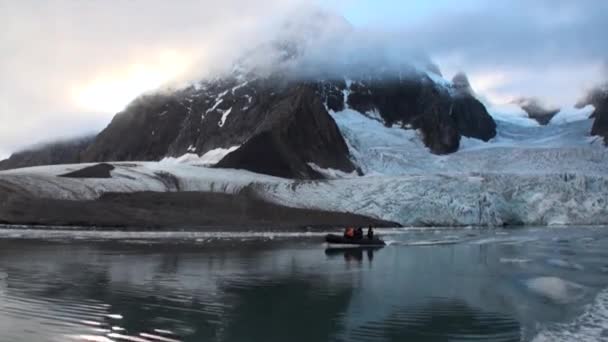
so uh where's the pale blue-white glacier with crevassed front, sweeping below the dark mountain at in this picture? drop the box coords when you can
[0,103,608,226]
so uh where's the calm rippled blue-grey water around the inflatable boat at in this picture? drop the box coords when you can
[0,228,608,342]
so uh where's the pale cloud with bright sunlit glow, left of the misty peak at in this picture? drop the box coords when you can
[0,0,304,154]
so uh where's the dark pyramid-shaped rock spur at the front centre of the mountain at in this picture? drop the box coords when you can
[217,85,354,178]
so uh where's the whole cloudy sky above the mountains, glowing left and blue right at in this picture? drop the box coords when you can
[0,0,608,158]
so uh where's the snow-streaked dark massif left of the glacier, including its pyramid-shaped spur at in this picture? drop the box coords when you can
[84,78,355,179]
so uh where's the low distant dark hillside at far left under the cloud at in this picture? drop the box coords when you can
[0,136,95,170]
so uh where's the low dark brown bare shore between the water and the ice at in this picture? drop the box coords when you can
[0,191,400,232]
